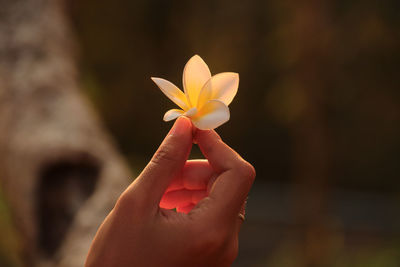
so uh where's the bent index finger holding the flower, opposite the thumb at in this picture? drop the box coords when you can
[195,130,255,221]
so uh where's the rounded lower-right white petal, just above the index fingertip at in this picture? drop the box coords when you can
[192,100,230,130]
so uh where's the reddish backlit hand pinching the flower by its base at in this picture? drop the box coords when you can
[85,117,255,267]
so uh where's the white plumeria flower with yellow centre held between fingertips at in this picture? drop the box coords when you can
[151,55,239,130]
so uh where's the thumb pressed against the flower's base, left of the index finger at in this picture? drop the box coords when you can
[127,117,193,213]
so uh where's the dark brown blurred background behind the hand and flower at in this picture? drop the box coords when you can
[0,0,400,267]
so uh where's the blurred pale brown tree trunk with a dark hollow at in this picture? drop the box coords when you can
[0,0,131,266]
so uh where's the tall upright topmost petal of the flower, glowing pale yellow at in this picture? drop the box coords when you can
[183,55,211,107]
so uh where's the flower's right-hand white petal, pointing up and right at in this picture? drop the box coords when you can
[206,72,239,106]
